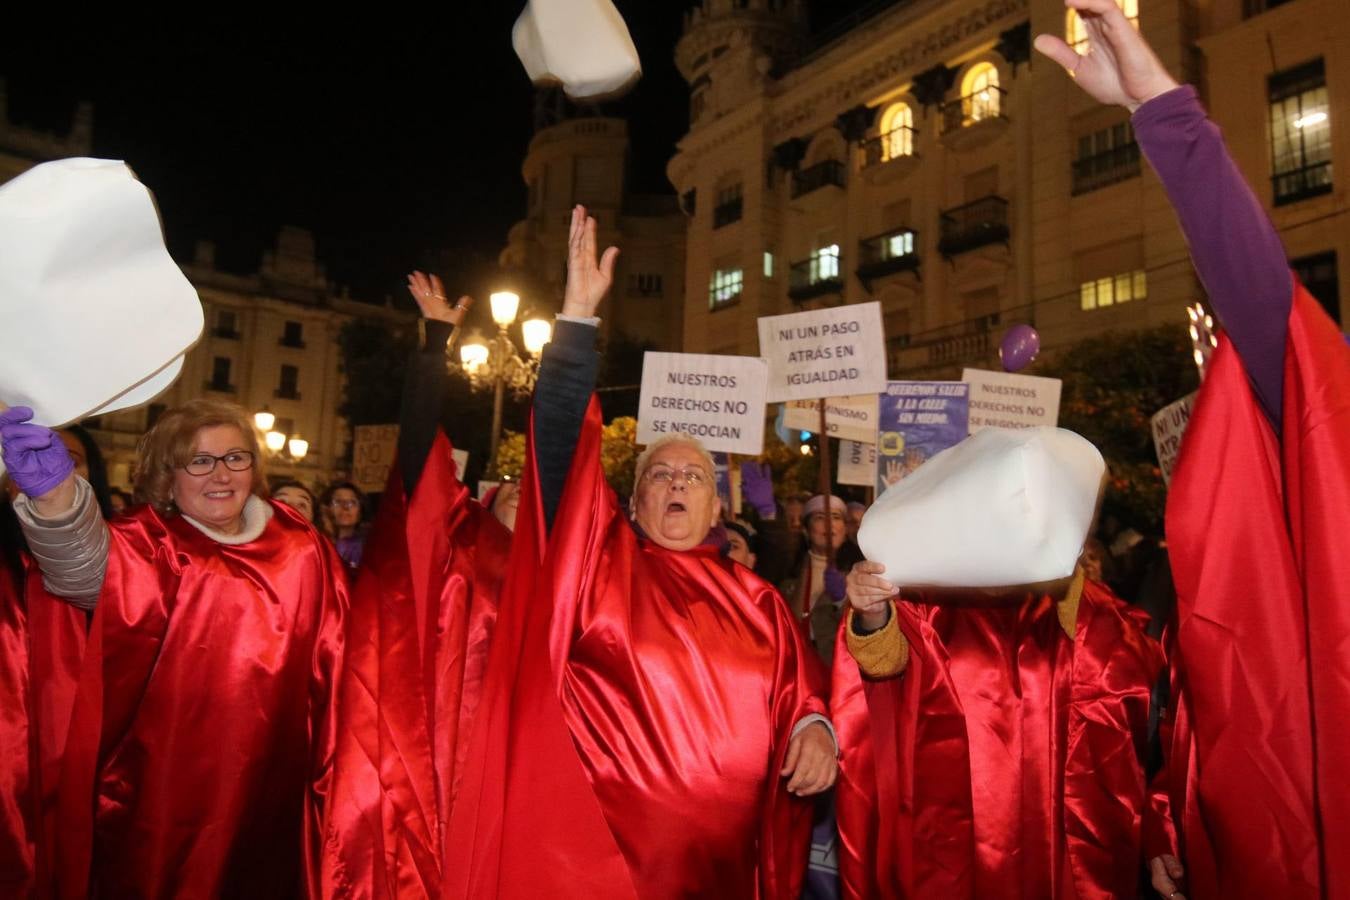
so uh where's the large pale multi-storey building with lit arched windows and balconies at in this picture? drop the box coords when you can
[668,0,1350,378]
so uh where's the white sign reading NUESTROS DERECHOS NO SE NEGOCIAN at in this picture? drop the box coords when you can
[637,352,767,455]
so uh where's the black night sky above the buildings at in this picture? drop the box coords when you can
[0,0,865,306]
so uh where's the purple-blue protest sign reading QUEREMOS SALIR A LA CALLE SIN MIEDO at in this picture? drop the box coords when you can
[875,382,971,493]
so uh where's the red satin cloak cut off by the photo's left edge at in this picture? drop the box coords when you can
[0,560,86,897]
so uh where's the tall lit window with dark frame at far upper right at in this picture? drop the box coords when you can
[1269,59,1331,206]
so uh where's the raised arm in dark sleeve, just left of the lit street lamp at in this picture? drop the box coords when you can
[398,271,474,497]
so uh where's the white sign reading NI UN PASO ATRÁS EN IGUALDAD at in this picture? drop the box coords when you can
[759,302,886,403]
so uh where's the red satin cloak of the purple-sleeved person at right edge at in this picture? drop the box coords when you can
[1164,285,1350,900]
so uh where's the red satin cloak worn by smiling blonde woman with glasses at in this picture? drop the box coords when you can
[47,503,347,899]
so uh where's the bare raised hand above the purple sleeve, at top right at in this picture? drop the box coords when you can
[1035,0,1177,112]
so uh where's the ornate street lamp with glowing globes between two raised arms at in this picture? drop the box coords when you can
[459,290,552,478]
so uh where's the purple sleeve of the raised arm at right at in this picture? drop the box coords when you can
[1133,85,1293,433]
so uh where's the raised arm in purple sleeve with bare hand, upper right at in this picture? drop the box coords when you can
[1035,0,1292,433]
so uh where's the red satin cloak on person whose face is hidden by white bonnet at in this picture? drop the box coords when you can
[832,582,1164,900]
